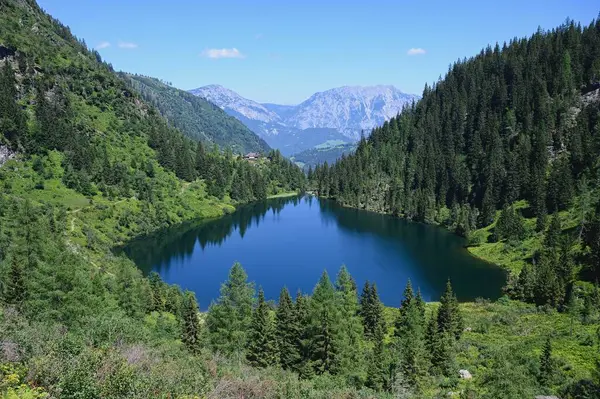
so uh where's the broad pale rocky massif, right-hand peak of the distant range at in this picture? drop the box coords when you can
[285,86,419,140]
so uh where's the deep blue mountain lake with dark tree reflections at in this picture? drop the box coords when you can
[124,196,506,310]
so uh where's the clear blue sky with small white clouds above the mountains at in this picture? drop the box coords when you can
[38,0,600,104]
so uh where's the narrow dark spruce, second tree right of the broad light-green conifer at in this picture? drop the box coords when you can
[275,287,301,370]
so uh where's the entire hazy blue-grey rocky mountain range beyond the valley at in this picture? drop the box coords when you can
[190,85,420,155]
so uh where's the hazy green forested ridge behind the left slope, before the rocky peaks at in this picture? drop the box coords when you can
[121,73,271,154]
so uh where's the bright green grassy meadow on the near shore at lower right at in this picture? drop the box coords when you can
[385,298,598,390]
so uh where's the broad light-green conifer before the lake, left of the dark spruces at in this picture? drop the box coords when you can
[206,263,255,354]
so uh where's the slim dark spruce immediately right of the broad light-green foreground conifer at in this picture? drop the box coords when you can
[246,288,277,367]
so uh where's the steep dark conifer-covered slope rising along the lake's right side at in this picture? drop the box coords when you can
[309,20,600,308]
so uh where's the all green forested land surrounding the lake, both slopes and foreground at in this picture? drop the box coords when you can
[0,0,600,399]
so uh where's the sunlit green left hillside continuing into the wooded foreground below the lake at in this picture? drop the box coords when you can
[0,0,600,399]
